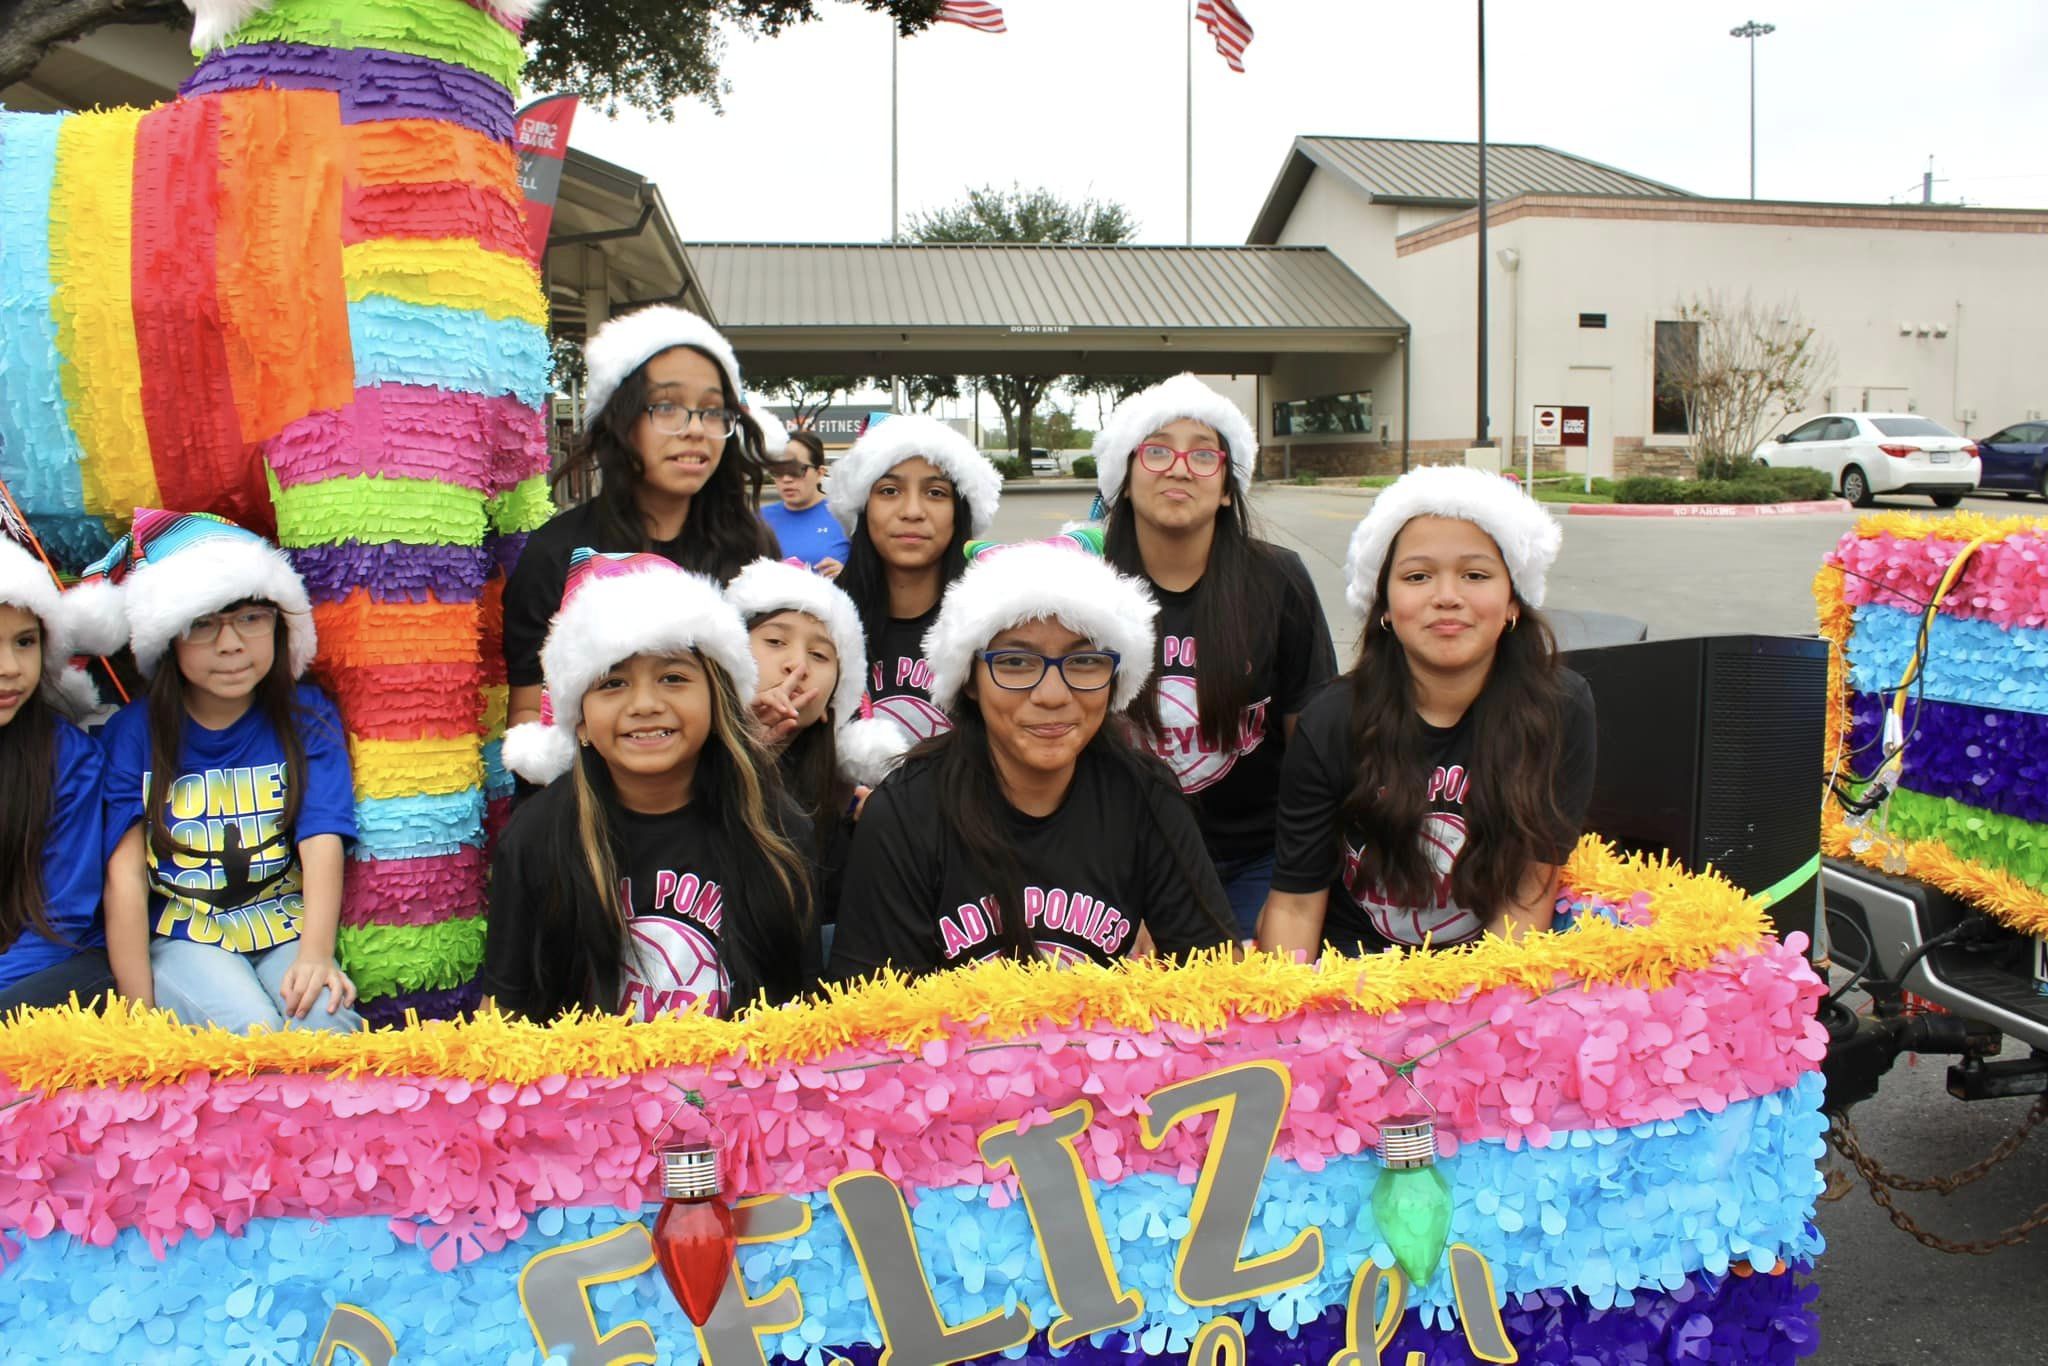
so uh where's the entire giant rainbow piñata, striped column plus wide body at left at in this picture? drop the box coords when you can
[0,0,551,1022]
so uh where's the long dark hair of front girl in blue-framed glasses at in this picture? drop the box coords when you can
[903,692,1229,963]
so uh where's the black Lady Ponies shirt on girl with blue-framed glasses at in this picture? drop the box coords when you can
[831,750,1231,979]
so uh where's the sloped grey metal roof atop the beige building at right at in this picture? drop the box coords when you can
[1247,133,1692,242]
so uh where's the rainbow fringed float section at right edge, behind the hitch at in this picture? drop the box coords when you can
[1815,512,2048,936]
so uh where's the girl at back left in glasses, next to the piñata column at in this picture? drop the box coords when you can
[504,303,780,725]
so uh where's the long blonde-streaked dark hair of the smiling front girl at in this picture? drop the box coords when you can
[516,659,813,1018]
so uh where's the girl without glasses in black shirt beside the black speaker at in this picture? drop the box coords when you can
[1260,467,1593,952]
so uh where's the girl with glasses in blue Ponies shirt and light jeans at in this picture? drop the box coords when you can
[87,510,362,1032]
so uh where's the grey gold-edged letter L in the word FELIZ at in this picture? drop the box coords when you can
[831,1171,1032,1366]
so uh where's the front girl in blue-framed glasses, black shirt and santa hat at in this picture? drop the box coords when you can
[831,541,1231,979]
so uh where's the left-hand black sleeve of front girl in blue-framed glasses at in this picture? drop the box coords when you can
[825,770,942,981]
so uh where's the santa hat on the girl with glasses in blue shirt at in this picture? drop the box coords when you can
[114,508,319,678]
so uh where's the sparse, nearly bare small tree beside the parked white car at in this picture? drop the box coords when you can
[1657,293,1835,479]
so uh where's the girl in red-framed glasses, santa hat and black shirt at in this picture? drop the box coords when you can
[1096,375,1337,938]
